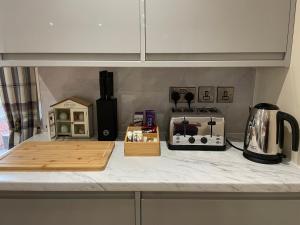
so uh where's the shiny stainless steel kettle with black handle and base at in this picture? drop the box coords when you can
[243,103,299,164]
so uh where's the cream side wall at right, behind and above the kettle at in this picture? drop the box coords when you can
[254,1,300,165]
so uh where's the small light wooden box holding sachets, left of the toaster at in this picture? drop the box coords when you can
[124,127,160,156]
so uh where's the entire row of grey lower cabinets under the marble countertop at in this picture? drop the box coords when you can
[0,192,300,225]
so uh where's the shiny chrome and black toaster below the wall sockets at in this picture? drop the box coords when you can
[168,108,226,151]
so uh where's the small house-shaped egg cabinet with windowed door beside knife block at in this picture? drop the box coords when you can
[48,97,93,139]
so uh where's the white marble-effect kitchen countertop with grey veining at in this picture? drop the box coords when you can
[0,134,300,192]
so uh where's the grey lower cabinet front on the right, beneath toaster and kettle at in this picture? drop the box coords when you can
[141,194,300,225]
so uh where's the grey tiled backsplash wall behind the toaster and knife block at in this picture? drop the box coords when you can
[39,68,255,138]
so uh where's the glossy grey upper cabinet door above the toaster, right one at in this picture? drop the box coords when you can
[146,0,291,53]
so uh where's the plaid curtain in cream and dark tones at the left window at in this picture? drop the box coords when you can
[0,67,40,148]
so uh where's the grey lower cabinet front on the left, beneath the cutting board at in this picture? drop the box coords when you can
[0,193,135,225]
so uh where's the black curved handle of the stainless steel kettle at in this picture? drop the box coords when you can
[277,111,299,151]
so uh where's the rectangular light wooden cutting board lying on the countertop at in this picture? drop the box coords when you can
[0,141,115,171]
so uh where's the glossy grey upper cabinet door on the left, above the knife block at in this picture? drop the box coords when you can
[0,0,140,53]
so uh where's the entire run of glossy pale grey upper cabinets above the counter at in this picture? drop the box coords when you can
[0,0,296,67]
